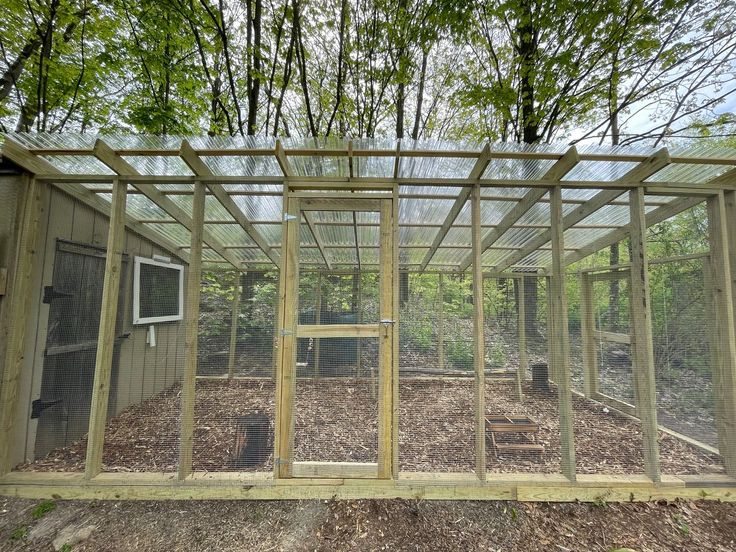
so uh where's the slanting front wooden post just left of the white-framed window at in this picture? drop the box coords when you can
[84,181,128,479]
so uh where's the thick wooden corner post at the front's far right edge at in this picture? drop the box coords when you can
[707,192,736,476]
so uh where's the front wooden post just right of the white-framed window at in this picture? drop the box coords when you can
[179,180,205,479]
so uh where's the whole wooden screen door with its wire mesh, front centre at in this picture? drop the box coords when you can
[276,194,394,479]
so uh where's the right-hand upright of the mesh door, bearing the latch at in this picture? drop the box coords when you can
[378,200,394,479]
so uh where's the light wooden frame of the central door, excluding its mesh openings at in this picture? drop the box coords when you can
[274,192,398,479]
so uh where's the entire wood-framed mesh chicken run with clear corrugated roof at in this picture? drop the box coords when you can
[0,133,736,501]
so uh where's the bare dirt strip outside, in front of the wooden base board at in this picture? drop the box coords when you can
[0,497,736,552]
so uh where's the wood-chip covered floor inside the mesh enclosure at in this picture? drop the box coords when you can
[17,378,723,475]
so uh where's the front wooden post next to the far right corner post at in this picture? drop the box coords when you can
[629,188,661,482]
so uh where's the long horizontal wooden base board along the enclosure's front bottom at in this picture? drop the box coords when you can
[0,472,736,502]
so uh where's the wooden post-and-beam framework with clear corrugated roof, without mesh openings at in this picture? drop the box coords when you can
[0,134,736,500]
